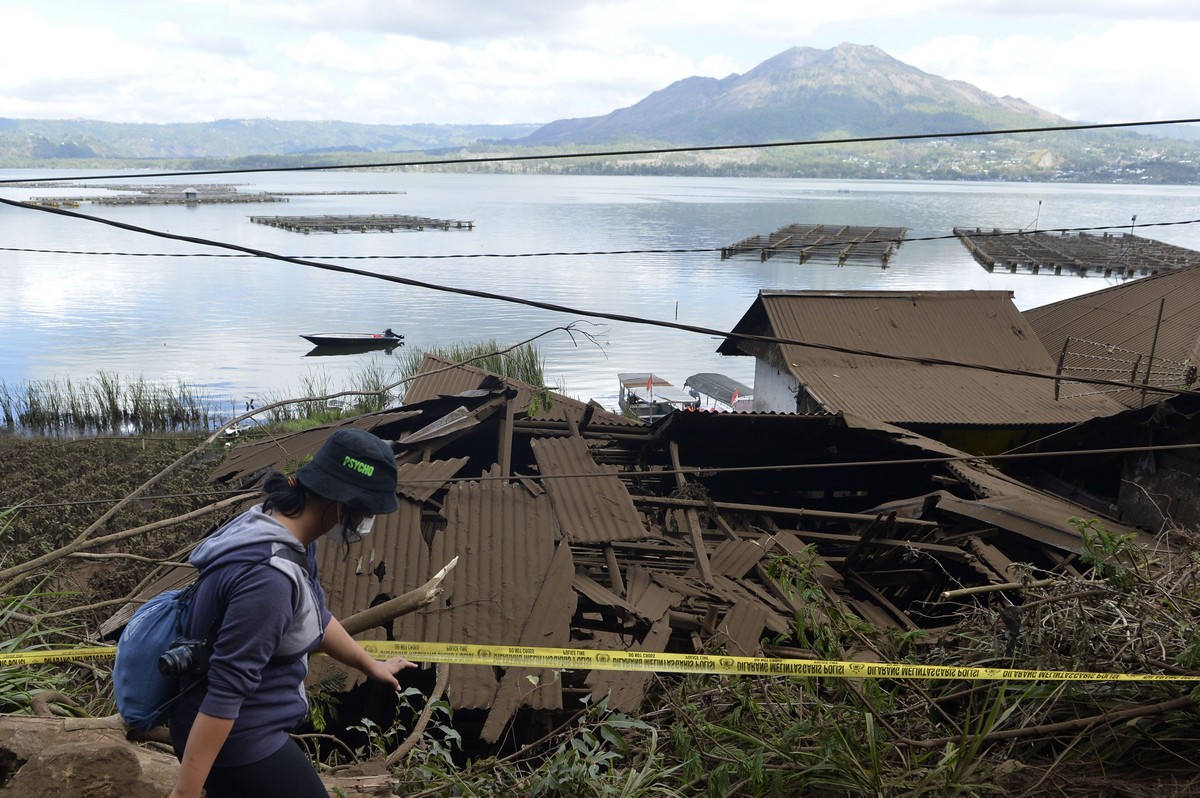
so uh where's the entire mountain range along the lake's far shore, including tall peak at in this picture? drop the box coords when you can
[0,44,1200,184]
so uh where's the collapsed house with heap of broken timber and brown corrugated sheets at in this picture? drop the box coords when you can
[169,355,1151,744]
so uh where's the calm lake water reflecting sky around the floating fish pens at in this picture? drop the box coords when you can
[0,169,1200,414]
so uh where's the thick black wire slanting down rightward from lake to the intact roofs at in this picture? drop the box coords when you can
[0,198,1195,396]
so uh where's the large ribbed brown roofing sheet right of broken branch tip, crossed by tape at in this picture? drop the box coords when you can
[424,480,554,709]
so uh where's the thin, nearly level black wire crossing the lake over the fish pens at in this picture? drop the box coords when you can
[0,218,1200,260]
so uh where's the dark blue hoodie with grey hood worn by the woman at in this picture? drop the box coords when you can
[170,505,331,767]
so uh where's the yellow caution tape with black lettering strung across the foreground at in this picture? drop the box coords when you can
[0,640,1200,682]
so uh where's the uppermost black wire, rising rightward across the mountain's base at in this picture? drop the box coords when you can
[0,119,1200,185]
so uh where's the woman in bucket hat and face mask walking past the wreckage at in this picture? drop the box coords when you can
[170,430,415,798]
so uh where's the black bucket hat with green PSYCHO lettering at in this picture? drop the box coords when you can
[295,428,400,515]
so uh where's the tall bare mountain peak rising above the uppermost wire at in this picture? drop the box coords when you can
[520,44,1067,146]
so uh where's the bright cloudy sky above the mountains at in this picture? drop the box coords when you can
[0,0,1200,125]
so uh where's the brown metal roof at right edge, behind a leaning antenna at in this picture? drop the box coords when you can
[1024,266,1200,407]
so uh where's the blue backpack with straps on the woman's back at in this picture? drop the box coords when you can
[113,548,308,732]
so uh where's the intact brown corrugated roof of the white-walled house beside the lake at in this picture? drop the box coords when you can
[719,290,1120,426]
